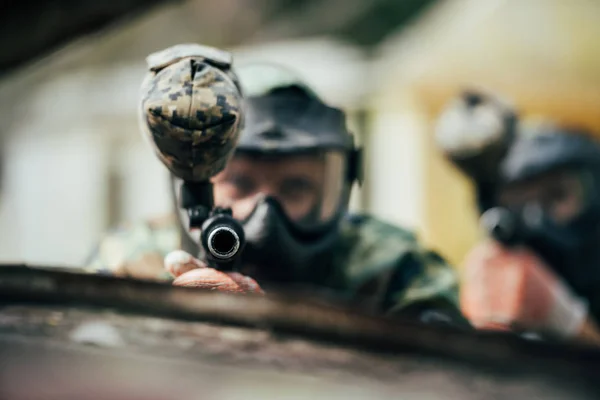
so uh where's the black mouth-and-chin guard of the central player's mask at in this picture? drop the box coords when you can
[242,197,339,283]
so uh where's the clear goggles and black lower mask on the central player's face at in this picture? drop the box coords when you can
[172,147,358,283]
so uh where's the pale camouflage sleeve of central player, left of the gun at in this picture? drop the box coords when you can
[85,216,179,281]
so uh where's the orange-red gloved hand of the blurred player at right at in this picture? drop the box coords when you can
[460,241,588,339]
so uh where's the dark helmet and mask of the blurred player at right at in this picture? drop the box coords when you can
[482,126,600,297]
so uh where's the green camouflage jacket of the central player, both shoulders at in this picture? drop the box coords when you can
[86,216,466,323]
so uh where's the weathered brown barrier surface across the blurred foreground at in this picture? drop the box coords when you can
[0,267,600,399]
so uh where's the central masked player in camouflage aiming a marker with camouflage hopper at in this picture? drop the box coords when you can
[88,46,468,325]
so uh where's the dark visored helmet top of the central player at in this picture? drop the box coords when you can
[236,63,362,183]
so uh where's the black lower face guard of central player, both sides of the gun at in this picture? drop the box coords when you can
[172,162,349,285]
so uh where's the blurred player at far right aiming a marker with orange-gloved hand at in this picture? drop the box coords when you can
[436,90,600,346]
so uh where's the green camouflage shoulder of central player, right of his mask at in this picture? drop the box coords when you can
[338,212,458,318]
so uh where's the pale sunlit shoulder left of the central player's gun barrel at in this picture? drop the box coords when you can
[86,215,180,272]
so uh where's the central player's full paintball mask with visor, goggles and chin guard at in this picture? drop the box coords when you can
[174,72,361,283]
